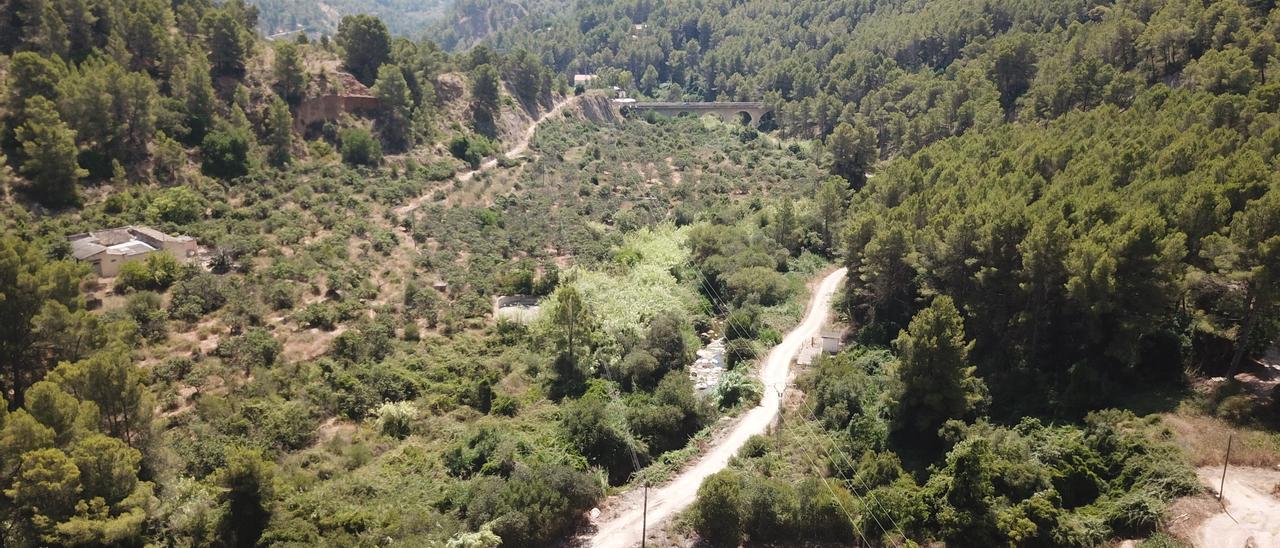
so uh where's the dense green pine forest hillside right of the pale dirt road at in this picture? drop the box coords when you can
[473,1,1280,545]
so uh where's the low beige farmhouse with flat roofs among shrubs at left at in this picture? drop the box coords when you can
[67,225,196,278]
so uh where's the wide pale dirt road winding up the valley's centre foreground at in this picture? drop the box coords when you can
[586,269,845,548]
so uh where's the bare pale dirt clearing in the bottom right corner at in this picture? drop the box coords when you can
[1192,466,1280,548]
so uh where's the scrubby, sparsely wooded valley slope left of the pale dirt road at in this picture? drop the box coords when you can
[0,1,844,547]
